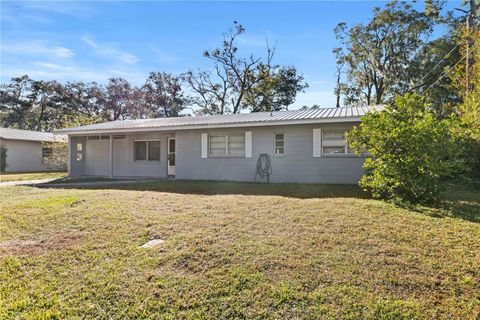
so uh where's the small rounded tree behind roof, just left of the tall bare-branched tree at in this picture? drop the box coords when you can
[142,72,186,118]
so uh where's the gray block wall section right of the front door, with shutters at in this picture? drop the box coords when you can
[175,123,364,184]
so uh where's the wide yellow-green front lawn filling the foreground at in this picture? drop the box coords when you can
[0,181,480,319]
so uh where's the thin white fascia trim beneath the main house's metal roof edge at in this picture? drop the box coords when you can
[56,116,361,135]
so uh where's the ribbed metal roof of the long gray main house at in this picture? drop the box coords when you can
[59,106,381,134]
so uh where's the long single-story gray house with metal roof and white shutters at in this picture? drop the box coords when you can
[61,107,375,184]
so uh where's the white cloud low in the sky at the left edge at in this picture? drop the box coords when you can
[2,41,75,58]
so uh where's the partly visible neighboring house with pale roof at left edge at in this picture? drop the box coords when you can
[0,128,67,172]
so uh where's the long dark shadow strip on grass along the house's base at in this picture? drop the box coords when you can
[37,178,369,199]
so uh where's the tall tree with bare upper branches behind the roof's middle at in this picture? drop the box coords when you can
[183,22,306,114]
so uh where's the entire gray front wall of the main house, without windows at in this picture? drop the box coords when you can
[70,123,365,184]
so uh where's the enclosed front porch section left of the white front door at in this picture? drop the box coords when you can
[68,132,176,178]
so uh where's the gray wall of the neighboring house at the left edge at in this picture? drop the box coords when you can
[1,139,47,172]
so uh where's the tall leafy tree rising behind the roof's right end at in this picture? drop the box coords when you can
[334,1,440,105]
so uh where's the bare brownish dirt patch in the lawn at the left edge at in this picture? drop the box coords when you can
[0,233,83,257]
